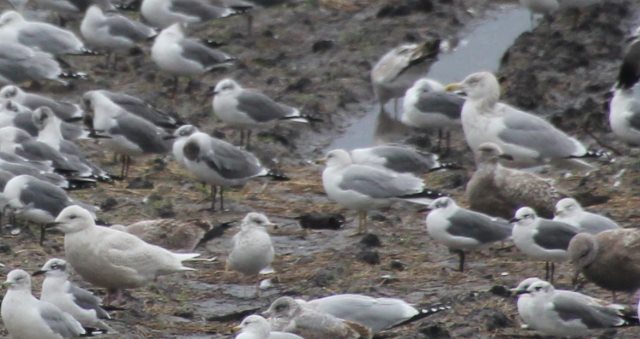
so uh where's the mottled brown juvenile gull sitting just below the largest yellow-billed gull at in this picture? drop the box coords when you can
[465,143,566,219]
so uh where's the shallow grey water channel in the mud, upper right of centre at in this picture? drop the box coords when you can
[328,5,531,150]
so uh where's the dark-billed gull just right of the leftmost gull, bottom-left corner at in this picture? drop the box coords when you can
[33,258,114,332]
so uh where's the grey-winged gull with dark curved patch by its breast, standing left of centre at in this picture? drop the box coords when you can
[172,126,279,210]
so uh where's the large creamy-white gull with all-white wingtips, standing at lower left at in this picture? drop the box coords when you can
[49,205,199,301]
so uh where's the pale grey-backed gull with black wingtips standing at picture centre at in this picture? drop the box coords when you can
[322,149,442,234]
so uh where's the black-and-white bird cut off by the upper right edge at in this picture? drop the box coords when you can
[609,29,640,146]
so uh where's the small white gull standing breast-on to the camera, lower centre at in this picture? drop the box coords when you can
[226,212,275,296]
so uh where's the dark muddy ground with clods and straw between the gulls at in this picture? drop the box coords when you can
[0,0,640,338]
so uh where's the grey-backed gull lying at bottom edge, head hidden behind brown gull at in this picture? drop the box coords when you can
[296,294,449,333]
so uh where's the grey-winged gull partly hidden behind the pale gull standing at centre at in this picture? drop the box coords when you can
[350,144,458,175]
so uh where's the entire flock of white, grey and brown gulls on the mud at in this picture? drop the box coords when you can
[0,0,640,339]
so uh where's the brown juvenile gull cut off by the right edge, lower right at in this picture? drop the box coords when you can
[568,228,640,293]
